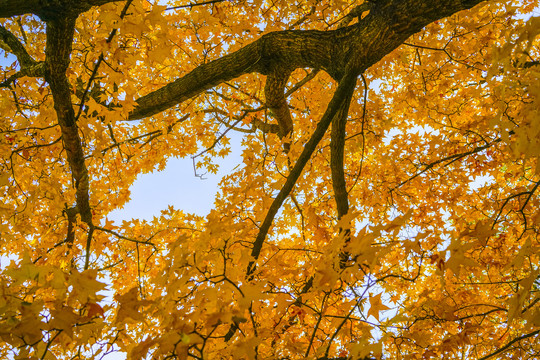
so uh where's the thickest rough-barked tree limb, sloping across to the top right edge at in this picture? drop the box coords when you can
[129,0,483,120]
